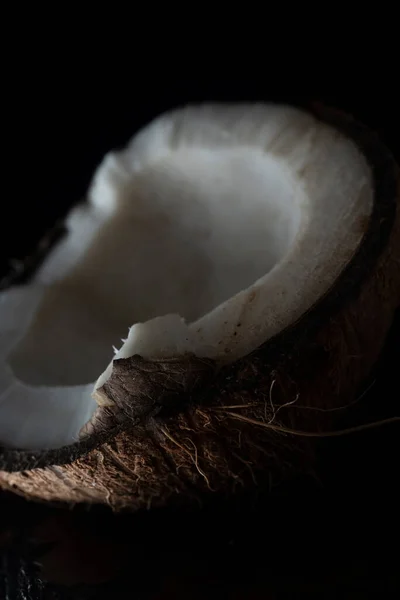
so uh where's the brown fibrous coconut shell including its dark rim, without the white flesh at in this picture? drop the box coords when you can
[0,107,400,509]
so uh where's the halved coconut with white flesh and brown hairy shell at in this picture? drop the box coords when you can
[0,104,400,509]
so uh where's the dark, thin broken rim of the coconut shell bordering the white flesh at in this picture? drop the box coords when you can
[0,104,398,472]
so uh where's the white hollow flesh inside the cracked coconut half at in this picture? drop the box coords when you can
[0,105,373,449]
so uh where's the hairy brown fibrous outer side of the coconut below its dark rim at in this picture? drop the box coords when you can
[0,188,400,509]
